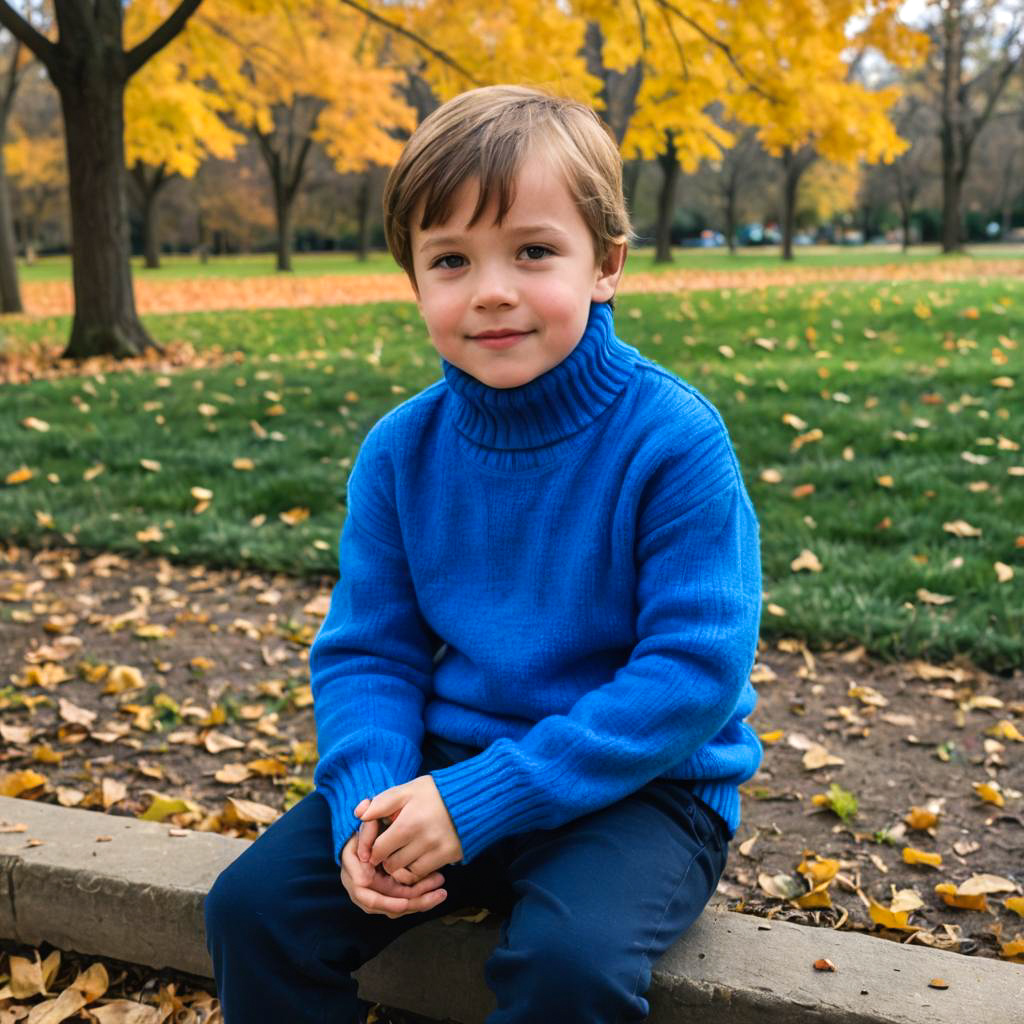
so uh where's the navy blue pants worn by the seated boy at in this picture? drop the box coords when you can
[205,735,728,1024]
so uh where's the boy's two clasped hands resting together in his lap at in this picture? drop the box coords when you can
[341,775,463,918]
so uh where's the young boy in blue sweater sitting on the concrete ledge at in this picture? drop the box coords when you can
[206,86,761,1024]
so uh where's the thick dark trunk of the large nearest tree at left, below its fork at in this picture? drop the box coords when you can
[58,65,156,359]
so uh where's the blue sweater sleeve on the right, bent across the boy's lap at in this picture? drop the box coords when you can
[431,461,761,863]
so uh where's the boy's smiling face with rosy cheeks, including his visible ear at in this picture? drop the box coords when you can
[412,159,626,388]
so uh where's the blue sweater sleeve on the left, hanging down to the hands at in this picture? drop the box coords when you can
[309,421,437,864]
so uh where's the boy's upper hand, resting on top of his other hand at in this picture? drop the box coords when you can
[355,775,462,884]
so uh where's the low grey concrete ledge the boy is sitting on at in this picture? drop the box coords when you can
[0,798,1024,1024]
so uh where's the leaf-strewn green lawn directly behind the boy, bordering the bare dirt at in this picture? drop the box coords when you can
[0,280,1024,671]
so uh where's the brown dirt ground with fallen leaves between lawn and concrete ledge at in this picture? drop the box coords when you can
[0,548,1024,1022]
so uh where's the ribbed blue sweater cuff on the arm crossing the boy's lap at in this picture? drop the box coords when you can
[430,739,551,864]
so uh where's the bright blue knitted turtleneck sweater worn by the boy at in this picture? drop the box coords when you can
[309,303,762,863]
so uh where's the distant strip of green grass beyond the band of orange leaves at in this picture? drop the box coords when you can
[12,245,1024,282]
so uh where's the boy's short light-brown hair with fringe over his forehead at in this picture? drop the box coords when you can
[383,85,634,282]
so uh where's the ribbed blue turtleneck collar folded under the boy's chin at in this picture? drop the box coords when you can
[441,302,639,450]
